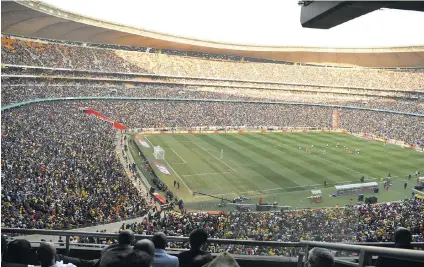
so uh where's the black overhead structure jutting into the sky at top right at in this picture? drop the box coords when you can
[299,1,424,29]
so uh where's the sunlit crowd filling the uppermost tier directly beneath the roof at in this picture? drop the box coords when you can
[2,37,424,90]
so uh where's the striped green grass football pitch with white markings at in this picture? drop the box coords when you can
[130,132,424,210]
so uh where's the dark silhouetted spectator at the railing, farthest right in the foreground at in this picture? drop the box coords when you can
[376,227,424,267]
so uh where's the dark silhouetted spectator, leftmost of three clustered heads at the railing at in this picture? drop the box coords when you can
[99,230,134,267]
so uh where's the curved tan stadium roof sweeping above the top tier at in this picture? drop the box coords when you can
[1,1,424,68]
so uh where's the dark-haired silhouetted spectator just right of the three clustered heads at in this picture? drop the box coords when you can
[178,229,213,267]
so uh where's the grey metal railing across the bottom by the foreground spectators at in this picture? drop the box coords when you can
[1,228,424,267]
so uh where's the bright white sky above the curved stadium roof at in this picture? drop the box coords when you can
[42,0,424,48]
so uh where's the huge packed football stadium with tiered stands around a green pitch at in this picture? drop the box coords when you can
[1,1,424,267]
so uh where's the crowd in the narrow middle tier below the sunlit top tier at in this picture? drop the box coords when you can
[1,79,424,114]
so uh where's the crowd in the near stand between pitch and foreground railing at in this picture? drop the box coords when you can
[113,199,424,256]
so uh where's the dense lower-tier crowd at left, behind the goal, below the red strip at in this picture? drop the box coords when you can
[1,103,146,229]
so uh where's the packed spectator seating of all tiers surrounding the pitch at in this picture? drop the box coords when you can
[1,37,424,255]
